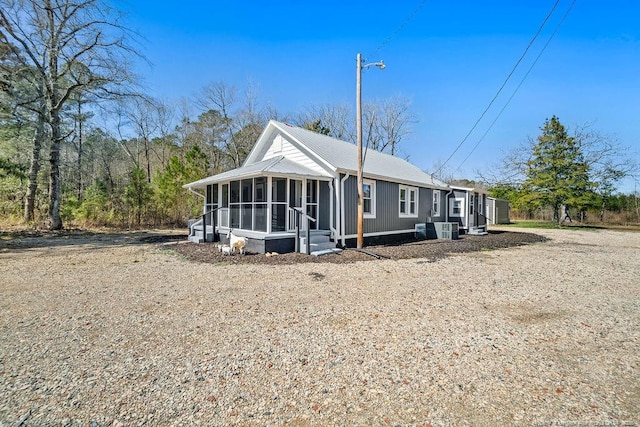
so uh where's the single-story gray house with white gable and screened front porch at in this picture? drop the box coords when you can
[184,120,468,253]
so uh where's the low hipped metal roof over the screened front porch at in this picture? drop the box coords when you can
[182,156,331,189]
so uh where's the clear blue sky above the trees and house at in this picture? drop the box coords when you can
[119,0,640,191]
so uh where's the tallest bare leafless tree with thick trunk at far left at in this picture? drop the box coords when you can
[0,0,137,229]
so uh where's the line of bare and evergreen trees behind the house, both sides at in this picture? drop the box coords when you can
[0,0,640,229]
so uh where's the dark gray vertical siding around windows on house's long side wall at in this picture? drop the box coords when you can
[344,177,432,235]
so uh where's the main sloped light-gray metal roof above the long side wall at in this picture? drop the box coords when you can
[269,120,448,188]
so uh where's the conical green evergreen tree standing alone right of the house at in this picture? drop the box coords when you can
[523,116,591,224]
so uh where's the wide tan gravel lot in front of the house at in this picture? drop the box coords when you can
[0,230,640,426]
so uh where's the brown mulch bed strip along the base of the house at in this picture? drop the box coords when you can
[171,231,548,264]
